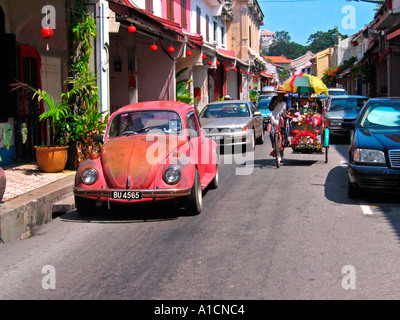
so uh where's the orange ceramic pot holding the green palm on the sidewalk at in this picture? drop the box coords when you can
[35,146,68,172]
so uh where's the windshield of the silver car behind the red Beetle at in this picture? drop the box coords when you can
[200,102,250,118]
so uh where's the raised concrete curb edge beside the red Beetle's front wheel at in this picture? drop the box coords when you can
[0,174,75,243]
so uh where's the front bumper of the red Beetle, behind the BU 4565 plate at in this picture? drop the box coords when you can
[73,187,194,200]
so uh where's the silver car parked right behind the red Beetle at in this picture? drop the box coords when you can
[200,100,264,150]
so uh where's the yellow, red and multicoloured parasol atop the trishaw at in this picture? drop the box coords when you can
[283,73,329,95]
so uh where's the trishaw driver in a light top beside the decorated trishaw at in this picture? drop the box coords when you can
[269,86,292,157]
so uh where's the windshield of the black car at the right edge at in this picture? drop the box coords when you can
[360,101,400,128]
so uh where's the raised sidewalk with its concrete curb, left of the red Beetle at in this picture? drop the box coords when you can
[0,164,75,243]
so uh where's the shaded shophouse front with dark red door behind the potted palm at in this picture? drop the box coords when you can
[0,0,69,164]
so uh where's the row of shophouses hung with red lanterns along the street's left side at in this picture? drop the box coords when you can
[0,0,265,164]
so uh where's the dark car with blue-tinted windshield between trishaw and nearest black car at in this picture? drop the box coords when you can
[326,96,368,136]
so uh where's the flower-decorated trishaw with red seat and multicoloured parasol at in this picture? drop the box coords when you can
[274,74,329,168]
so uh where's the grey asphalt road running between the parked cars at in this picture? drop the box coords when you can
[0,133,400,300]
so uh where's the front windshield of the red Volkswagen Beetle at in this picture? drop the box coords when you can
[108,110,182,138]
